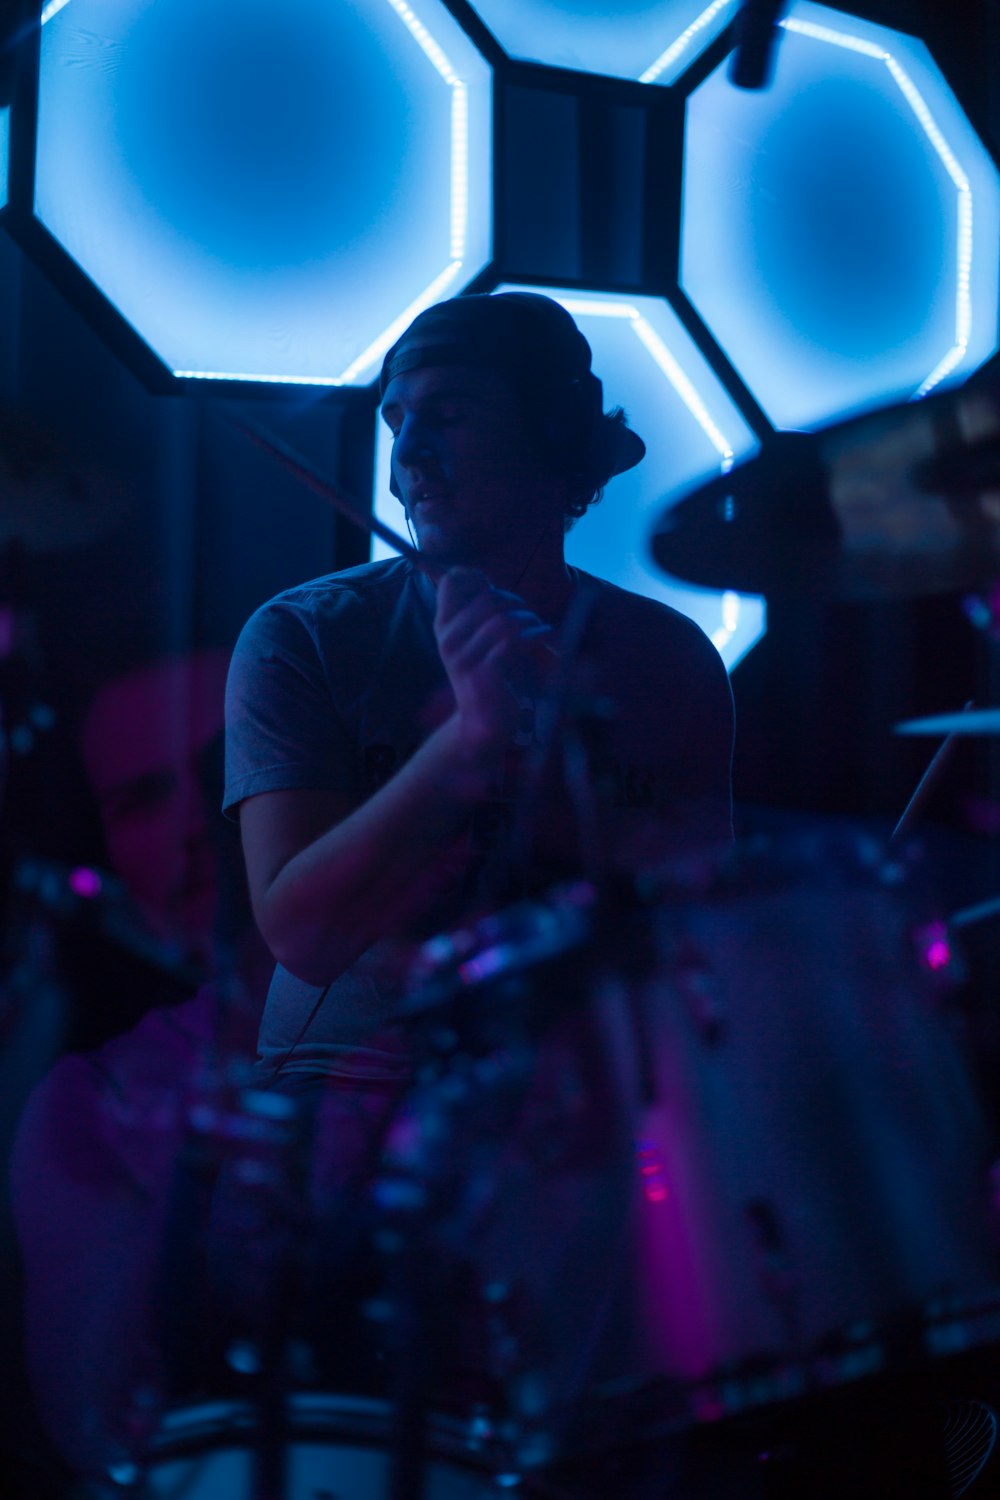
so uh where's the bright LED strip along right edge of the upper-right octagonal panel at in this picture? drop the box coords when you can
[780,17,973,401]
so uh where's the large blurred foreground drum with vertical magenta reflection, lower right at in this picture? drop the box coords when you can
[612,831,1000,1418]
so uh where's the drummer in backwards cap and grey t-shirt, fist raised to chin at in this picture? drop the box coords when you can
[225,293,732,1088]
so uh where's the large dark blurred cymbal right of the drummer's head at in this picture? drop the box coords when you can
[651,373,1000,600]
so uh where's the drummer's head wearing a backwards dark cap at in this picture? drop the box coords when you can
[381,293,645,564]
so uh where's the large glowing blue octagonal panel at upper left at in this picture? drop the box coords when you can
[34,0,492,386]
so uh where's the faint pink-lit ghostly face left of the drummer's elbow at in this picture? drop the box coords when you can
[82,651,228,957]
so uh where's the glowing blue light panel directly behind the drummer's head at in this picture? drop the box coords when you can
[372,287,765,668]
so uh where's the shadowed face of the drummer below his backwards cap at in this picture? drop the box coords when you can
[382,366,565,566]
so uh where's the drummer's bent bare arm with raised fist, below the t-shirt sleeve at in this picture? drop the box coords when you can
[240,569,560,984]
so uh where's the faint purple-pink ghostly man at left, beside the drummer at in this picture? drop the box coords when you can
[10,650,267,1476]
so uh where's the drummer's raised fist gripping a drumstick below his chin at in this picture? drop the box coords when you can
[435,567,556,752]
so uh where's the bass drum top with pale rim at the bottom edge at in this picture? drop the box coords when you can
[139,1392,570,1500]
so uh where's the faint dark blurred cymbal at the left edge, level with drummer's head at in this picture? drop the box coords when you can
[0,411,130,552]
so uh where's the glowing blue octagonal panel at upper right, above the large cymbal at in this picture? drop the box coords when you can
[681,0,1000,428]
